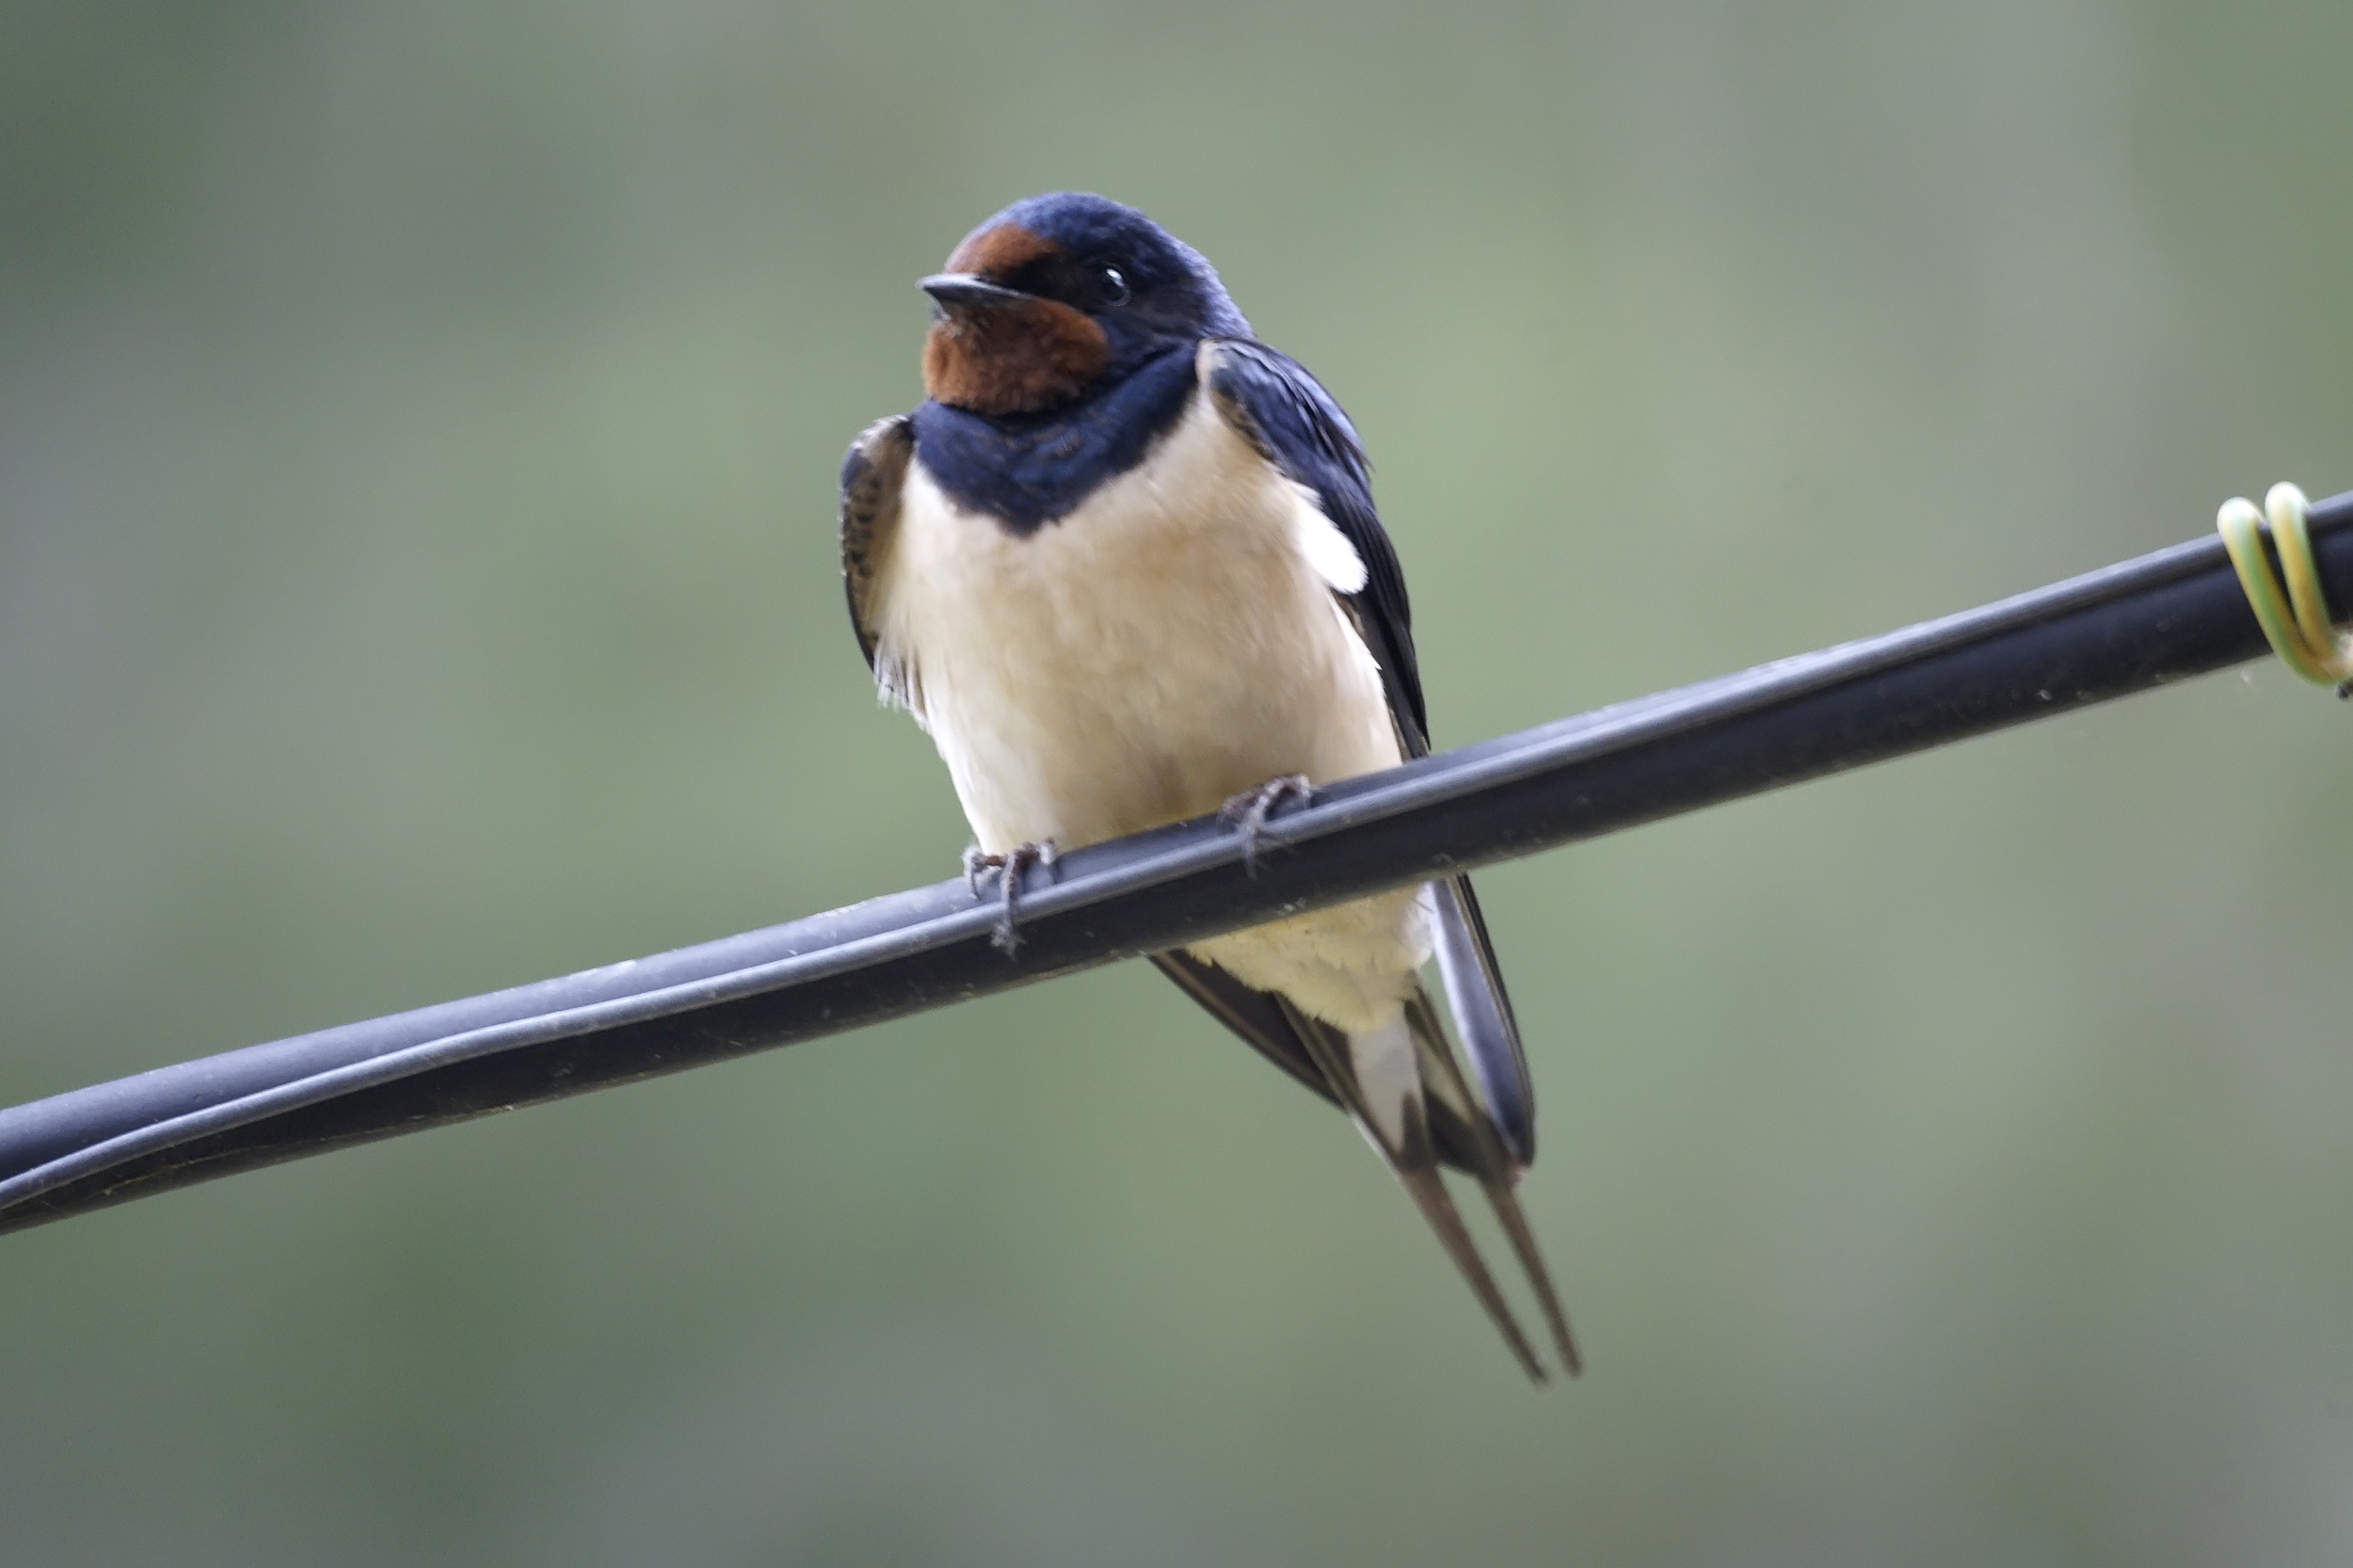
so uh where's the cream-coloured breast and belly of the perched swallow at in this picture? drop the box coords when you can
[878,383,1429,1029]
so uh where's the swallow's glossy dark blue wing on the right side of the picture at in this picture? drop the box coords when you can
[1209,339,1537,1165]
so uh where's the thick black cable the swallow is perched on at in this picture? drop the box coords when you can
[0,494,2353,1231]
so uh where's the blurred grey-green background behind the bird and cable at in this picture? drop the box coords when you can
[0,0,2353,1568]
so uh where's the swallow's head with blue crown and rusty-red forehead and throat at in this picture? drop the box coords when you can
[922,191,1250,414]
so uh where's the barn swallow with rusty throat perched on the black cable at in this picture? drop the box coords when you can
[842,193,1579,1382]
